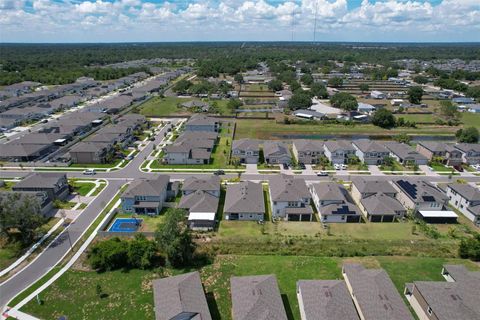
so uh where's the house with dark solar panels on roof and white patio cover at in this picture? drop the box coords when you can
[393,179,457,223]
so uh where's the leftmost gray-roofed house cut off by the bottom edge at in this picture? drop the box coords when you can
[152,271,212,320]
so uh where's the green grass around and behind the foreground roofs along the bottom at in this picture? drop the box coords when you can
[22,255,478,320]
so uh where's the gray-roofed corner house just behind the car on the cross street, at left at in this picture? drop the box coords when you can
[69,141,113,163]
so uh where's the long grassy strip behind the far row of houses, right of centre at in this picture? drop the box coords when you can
[235,119,458,139]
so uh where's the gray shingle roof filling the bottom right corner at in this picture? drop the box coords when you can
[413,265,480,320]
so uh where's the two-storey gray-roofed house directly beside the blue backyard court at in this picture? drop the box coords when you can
[121,175,170,215]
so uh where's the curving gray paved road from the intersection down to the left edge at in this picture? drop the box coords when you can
[0,180,123,309]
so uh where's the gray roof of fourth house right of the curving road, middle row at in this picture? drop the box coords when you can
[269,174,311,201]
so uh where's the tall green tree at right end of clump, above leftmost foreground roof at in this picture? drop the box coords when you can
[155,209,195,267]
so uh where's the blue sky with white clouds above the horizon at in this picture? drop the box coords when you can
[0,0,480,43]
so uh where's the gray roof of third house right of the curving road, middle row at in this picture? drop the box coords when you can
[223,181,265,213]
